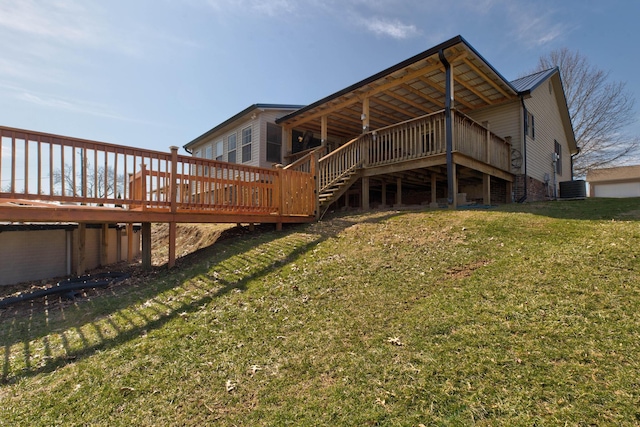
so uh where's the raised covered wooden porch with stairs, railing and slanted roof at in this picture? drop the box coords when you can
[278,36,518,212]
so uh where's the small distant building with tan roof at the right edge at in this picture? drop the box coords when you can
[587,165,640,197]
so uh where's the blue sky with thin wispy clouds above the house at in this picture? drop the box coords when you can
[0,0,640,153]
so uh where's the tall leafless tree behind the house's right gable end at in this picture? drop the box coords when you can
[537,48,640,176]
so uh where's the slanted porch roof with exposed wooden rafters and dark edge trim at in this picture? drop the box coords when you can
[277,36,518,137]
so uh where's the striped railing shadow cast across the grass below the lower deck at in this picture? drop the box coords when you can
[0,211,402,384]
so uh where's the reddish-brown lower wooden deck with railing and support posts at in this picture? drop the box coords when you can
[0,127,317,266]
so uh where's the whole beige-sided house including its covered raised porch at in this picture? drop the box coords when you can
[185,36,578,215]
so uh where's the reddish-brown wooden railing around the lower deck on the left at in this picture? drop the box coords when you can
[0,127,315,216]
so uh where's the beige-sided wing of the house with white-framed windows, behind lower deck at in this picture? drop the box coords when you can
[184,104,303,167]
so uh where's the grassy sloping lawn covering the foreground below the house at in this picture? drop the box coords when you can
[0,199,640,426]
